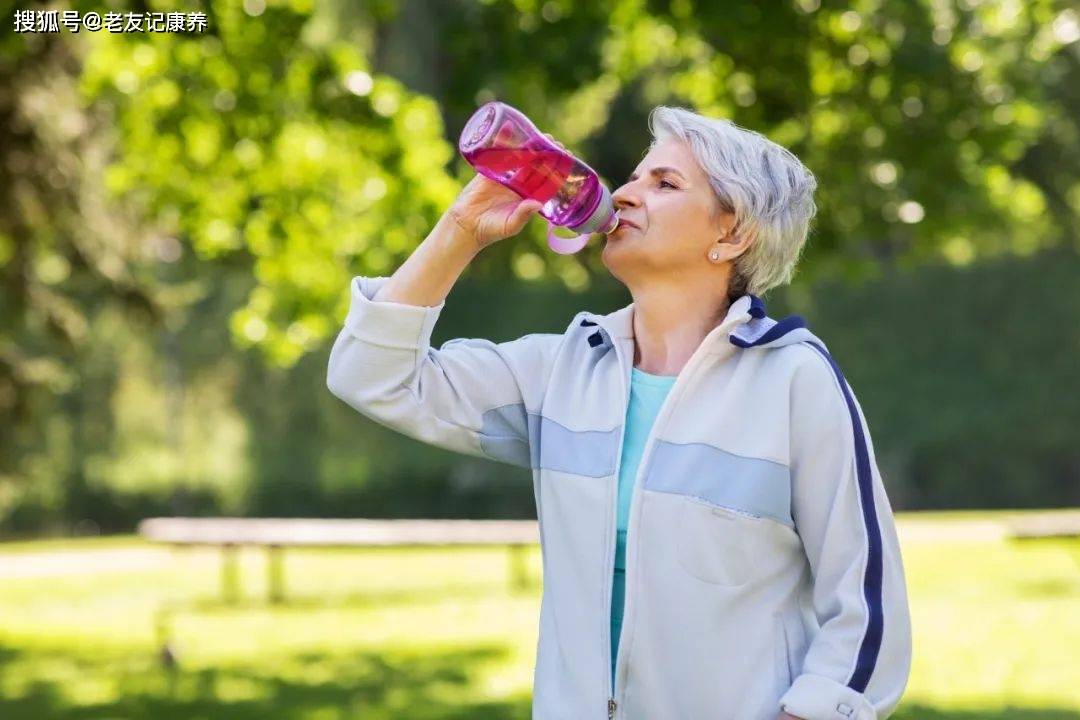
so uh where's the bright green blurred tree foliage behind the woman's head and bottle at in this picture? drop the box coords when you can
[76,0,1080,365]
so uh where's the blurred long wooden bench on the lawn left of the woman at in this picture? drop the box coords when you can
[138,517,540,602]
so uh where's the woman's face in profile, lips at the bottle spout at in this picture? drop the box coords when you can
[602,138,732,289]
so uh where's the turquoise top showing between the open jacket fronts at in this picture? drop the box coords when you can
[611,367,675,684]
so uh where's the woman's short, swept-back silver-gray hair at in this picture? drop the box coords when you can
[649,106,818,299]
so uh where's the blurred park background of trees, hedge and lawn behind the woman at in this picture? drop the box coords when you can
[0,0,1080,720]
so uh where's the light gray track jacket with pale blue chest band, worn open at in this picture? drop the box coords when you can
[327,277,912,720]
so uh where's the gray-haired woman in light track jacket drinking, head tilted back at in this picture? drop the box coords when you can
[327,107,910,720]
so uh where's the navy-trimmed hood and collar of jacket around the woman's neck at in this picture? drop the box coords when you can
[579,294,824,352]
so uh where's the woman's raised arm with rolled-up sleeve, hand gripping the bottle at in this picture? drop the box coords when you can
[326,176,562,467]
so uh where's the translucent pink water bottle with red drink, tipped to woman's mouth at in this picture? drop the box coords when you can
[458,101,619,255]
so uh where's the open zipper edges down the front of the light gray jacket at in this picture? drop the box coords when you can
[605,323,747,720]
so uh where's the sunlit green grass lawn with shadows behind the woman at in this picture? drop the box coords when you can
[0,513,1080,720]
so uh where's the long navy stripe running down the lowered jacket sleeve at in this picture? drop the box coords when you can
[806,340,885,693]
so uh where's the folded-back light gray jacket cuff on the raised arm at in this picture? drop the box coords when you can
[345,276,446,350]
